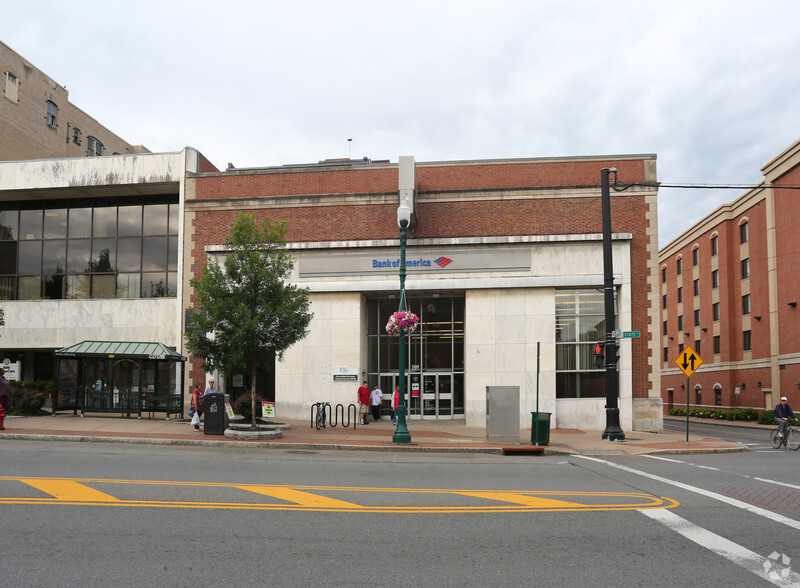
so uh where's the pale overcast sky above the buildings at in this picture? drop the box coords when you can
[0,0,800,246]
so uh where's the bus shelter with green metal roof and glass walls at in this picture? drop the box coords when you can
[53,341,186,420]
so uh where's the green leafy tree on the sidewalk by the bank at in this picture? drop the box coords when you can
[186,214,313,429]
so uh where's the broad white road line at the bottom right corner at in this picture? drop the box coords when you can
[639,509,800,586]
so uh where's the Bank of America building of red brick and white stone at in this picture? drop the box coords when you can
[188,155,662,431]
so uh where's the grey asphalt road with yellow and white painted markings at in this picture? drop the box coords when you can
[0,441,800,587]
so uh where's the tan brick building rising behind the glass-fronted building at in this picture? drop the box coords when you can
[0,42,148,161]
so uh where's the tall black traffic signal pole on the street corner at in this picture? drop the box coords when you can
[600,168,625,441]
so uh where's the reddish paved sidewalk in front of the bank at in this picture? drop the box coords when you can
[0,414,747,455]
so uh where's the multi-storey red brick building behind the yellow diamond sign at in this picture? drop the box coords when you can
[659,141,800,410]
